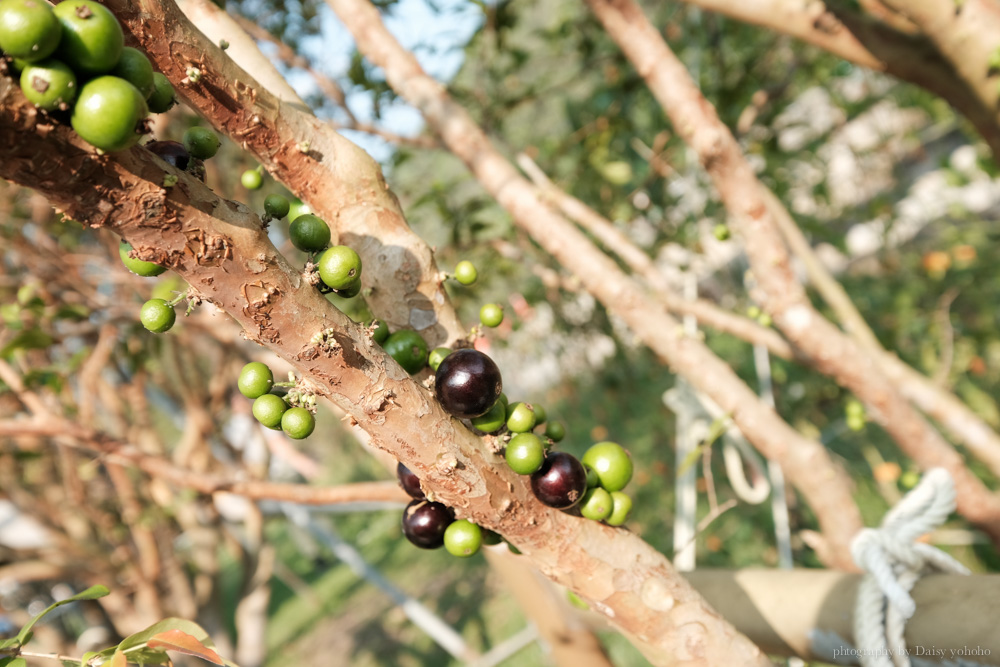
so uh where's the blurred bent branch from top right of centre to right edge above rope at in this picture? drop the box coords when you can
[587,0,1000,541]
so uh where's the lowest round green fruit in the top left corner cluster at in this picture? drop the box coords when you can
[72,76,147,151]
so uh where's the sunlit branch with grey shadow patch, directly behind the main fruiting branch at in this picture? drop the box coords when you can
[107,0,467,347]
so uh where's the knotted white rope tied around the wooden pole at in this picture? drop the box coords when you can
[851,468,969,667]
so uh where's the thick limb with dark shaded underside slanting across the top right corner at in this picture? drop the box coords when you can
[672,0,1000,156]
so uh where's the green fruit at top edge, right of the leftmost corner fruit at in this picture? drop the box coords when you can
[53,0,122,74]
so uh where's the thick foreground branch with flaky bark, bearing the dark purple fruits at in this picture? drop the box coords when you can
[0,75,769,667]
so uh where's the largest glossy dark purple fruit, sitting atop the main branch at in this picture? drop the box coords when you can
[434,349,503,419]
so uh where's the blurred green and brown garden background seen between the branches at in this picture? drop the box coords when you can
[0,0,1000,667]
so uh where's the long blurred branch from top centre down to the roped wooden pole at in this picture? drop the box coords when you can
[327,0,861,569]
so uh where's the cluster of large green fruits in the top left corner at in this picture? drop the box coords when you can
[0,0,174,151]
